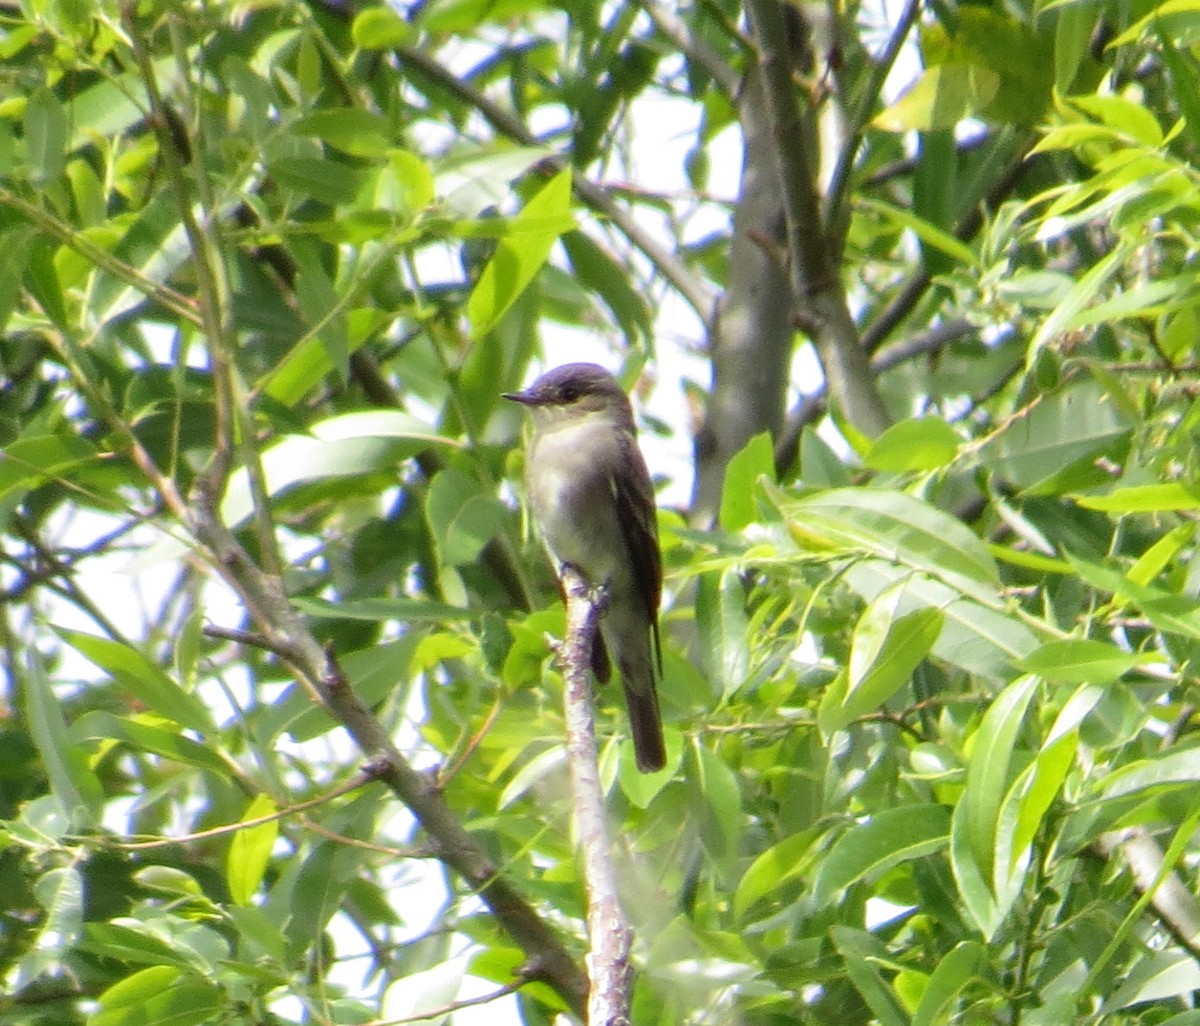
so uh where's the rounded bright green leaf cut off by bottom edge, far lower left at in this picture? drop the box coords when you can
[88,966,224,1026]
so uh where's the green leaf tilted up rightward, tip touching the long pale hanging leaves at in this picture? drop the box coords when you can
[812,805,950,908]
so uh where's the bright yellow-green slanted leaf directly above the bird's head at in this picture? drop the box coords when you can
[467,169,571,337]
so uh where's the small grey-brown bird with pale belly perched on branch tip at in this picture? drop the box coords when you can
[504,364,666,773]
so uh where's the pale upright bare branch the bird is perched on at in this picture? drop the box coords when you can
[563,566,634,1026]
